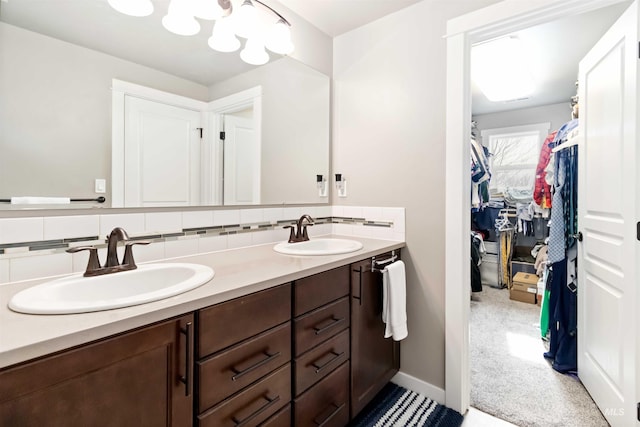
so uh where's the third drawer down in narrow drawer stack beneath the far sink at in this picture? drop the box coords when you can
[295,329,349,395]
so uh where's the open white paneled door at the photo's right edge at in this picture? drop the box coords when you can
[578,2,640,427]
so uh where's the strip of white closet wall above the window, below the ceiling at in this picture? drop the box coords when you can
[473,100,571,131]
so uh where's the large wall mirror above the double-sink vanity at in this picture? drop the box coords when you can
[0,0,330,209]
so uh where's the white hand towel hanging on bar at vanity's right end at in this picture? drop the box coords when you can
[382,261,408,341]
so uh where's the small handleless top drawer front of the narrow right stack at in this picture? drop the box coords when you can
[294,265,350,316]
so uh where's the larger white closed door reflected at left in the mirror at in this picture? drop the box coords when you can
[124,96,201,207]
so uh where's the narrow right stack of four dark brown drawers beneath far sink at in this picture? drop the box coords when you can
[293,266,351,427]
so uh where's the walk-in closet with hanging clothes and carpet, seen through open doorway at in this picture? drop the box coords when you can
[469,2,631,426]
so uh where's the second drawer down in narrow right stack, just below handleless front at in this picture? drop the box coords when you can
[294,297,349,356]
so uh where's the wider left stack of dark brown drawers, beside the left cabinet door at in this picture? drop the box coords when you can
[196,284,291,427]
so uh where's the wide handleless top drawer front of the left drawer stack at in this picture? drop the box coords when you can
[196,284,291,358]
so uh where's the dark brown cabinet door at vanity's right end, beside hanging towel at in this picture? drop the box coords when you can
[351,257,400,417]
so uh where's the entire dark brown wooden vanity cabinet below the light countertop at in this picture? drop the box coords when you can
[0,251,400,427]
